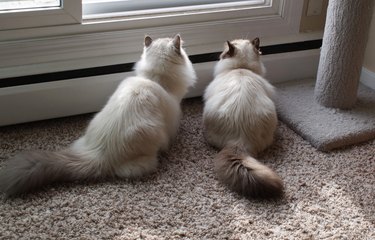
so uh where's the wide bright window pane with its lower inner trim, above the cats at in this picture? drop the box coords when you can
[83,0,274,27]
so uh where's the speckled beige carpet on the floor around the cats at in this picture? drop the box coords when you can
[0,99,375,239]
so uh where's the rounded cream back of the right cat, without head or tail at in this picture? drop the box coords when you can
[203,69,277,152]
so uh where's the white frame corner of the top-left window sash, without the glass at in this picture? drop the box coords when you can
[0,0,82,31]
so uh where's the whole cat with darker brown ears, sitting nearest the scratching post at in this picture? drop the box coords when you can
[203,38,283,198]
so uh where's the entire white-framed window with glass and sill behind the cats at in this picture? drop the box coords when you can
[0,0,303,78]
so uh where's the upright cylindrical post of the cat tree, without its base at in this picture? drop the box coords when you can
[314,0,374,109]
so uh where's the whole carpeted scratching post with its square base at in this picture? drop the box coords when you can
[275,0,375,151]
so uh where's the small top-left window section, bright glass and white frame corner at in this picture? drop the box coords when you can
[0,0,82,30]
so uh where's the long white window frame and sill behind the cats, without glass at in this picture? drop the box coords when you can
[0,0,303,79]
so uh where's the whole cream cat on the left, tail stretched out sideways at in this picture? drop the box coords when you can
[0,35,196,197]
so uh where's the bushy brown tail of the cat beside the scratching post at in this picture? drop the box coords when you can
[214,145,284,198]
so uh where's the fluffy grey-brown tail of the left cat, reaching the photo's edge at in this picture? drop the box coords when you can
[0,150,98,198]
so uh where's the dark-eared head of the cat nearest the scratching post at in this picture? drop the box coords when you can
[215,38,265,76]
